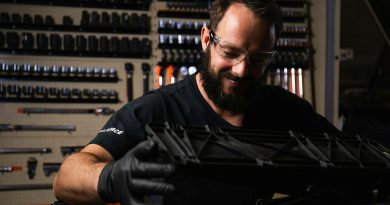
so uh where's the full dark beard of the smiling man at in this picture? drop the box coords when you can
[200,45,261,113]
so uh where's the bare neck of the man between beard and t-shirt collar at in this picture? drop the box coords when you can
[195,73,244,127]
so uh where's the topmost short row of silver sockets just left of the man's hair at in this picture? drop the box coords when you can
[158,19,208,35]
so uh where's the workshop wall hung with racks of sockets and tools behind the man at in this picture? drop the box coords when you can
[0,0,322,205]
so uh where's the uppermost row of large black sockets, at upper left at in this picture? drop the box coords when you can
[0,10,151,34]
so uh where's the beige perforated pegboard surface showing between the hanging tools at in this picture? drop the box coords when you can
[0,0,312,205]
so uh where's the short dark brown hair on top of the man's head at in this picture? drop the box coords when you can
[210,0,283,42]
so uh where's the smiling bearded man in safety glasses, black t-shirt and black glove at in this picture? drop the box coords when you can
[54,0,338,205]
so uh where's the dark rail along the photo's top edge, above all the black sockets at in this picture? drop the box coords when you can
[0,0,151,11]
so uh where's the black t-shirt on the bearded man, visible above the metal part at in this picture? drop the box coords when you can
[90,74,337,159]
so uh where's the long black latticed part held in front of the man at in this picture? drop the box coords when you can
[145,123,390,204]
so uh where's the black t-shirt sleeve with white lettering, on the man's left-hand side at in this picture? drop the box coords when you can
[89,93,164,160]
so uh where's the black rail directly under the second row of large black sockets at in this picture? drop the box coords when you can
[0,48,150,59]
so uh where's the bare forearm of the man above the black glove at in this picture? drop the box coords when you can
[53,152,106,204]
